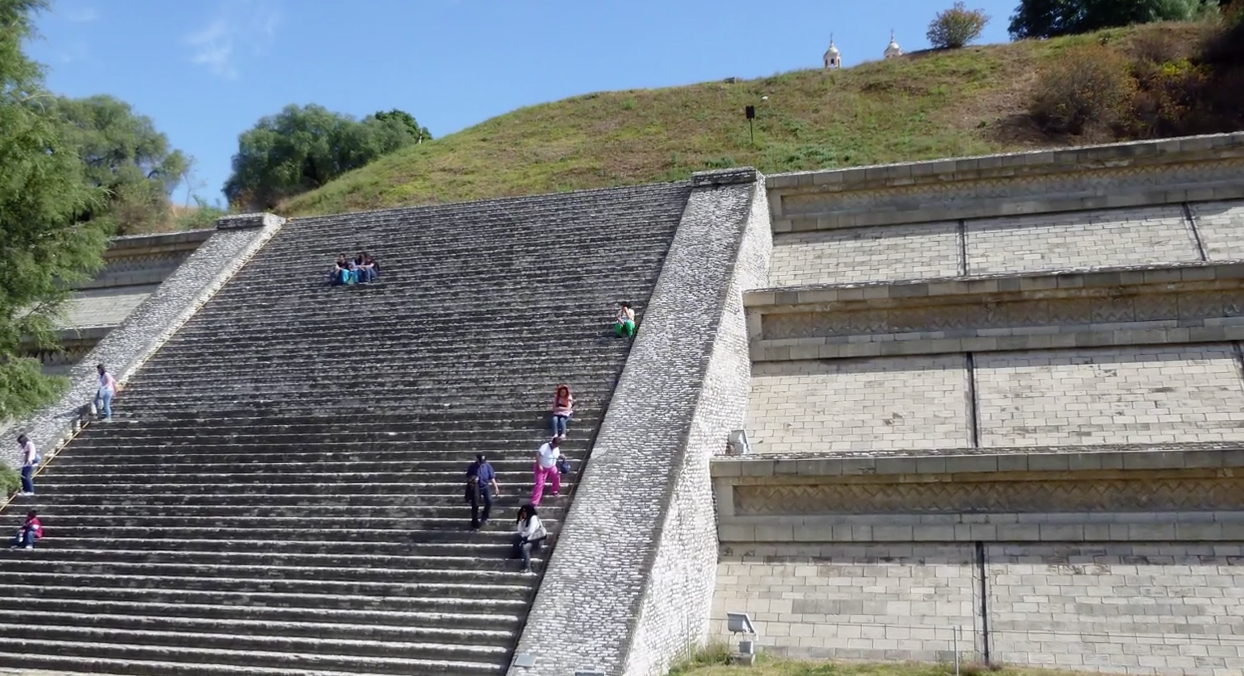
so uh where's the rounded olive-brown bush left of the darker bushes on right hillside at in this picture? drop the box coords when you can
[1029,45,1136,134]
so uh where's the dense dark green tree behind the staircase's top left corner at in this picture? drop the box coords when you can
[224,105,432,209]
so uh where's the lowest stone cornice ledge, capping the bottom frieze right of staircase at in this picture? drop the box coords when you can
[710,443,1244,483]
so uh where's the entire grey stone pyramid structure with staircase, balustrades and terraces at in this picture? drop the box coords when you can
[7,133,1244,676]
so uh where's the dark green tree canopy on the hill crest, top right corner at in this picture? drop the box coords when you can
[1008,0,1228,40]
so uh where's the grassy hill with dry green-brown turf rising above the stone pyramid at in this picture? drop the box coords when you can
[280,25,1204,215]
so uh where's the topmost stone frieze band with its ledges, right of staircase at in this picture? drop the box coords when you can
[768,132,1244,233]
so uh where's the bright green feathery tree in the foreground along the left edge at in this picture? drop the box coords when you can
[0,0,109,420]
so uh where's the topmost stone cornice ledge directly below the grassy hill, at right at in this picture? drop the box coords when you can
[766,132,1244,192]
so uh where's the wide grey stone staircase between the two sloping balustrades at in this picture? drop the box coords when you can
[0,184,690,676]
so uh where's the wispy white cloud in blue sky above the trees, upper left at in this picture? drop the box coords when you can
[185,1,280,80]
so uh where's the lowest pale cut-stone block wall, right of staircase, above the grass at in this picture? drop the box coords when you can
[713,543,1244,676]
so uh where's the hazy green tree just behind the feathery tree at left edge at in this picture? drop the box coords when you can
[55,96,190,234]
